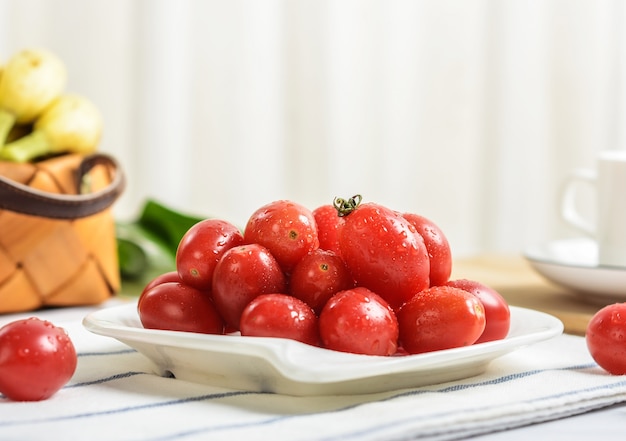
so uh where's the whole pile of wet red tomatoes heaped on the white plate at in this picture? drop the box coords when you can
[138,196,510,356]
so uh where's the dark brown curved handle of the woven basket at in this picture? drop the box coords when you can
[0,153,126,219]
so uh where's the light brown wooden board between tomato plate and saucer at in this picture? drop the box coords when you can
[451,256,603,335]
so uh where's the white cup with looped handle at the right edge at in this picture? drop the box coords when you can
[561,150,626,268]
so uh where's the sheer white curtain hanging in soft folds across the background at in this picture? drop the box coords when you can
[0,0,626,256]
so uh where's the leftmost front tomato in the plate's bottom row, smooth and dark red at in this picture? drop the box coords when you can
[137,282,224,334]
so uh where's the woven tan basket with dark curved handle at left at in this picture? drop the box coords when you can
[0,154,125,313]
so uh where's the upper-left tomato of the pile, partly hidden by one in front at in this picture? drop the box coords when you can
[176,219,243,290]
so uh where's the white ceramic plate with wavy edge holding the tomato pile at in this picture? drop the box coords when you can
[83,304,563,396]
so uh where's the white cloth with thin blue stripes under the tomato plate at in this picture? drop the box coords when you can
[0,305,626,441]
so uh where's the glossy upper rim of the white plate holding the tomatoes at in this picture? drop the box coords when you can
[82,303,564,384]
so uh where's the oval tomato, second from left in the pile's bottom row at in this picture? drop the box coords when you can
[240,294,319,346]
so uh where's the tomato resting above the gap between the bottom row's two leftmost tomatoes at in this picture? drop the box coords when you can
[212,244,287,330]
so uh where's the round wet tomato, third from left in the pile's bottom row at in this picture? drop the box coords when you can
[319,287,398,356]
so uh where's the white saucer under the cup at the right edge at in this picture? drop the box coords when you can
[525,238,626,304]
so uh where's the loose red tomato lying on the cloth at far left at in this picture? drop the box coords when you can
[0,317,77,401]
